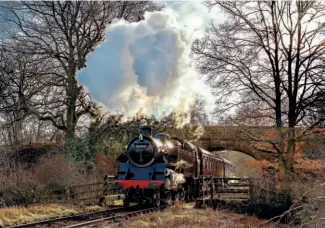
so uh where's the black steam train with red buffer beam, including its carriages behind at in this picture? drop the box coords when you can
[114,126,234,207]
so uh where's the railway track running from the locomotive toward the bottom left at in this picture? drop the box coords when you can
[11,206,166,228]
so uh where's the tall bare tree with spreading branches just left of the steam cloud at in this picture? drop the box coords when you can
[1,1,161,144]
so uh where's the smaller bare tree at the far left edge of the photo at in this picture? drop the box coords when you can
[0,41,52,145]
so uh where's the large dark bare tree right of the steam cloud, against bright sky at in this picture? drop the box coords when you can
[192,1,325,171]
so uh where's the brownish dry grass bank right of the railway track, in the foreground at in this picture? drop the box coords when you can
[122,204,279,228]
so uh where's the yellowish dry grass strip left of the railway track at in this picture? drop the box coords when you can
[0,204,79,226]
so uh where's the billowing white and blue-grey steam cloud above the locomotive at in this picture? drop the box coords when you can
[78,2,221,121]
